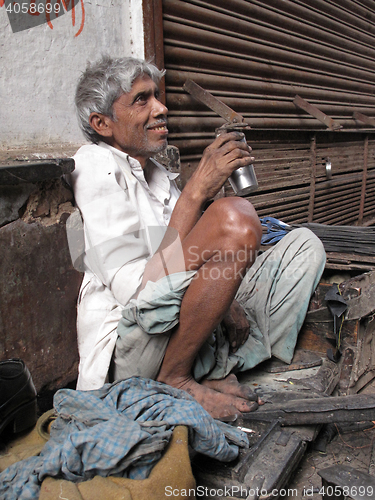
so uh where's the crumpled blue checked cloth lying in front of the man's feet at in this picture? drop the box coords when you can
[0,377,248,500]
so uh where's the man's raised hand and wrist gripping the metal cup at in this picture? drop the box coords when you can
[188,132,254,203]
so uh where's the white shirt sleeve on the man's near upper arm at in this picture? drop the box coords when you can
[71,145,150,305]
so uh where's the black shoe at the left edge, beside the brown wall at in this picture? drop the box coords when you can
[0,359,37,436]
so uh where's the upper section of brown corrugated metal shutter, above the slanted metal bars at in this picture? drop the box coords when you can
[163,0,375,138]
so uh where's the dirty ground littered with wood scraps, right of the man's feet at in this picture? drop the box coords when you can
[193,271,375,500]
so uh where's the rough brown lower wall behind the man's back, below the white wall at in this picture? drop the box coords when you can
[0,178,82,392]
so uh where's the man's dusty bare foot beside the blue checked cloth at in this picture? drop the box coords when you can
[159,377,258,420]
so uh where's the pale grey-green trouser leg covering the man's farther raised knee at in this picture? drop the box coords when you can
[194,228,325,380]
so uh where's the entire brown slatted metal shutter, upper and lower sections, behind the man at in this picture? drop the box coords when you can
[146,0,375,224]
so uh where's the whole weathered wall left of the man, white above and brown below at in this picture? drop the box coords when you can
[0,0,144,393]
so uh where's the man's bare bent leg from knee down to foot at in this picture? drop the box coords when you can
[157,199,261,418]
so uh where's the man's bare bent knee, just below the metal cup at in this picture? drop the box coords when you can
[207,197,262,250]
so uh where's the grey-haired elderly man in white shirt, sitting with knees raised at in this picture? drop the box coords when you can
[71,57,325,418]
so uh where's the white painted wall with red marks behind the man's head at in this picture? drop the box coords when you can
[0,0,144,150]
